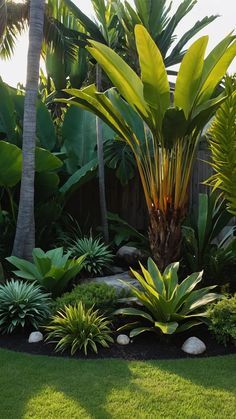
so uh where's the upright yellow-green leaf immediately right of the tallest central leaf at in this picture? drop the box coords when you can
[174,36,208,119]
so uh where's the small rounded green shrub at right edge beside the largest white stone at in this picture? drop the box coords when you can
[208,294,236,345]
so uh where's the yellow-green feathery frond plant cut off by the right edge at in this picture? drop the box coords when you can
[207,75,236,216]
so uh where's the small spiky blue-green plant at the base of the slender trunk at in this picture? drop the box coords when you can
[69,237,113,276]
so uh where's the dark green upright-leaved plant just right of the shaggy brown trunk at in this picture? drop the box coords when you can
[182,192,236,281]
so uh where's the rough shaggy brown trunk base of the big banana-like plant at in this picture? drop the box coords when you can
[148,208,182,271]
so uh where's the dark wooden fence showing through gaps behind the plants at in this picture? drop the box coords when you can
[69,142,212,230]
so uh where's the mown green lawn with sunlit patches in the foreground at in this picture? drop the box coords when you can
[0,350,236,419]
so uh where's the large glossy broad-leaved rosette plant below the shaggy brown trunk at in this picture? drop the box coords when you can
[115,258,220,337]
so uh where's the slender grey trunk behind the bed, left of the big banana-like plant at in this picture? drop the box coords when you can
[96,64,109,243]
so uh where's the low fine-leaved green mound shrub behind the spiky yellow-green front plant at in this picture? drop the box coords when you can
[53,282,119,311]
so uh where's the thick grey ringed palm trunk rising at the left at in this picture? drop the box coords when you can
[12,0,45,259]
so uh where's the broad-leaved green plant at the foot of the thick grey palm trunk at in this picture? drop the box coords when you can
[6,247,86,296]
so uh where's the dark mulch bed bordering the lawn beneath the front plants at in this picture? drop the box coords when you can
[0,327,236,360]
